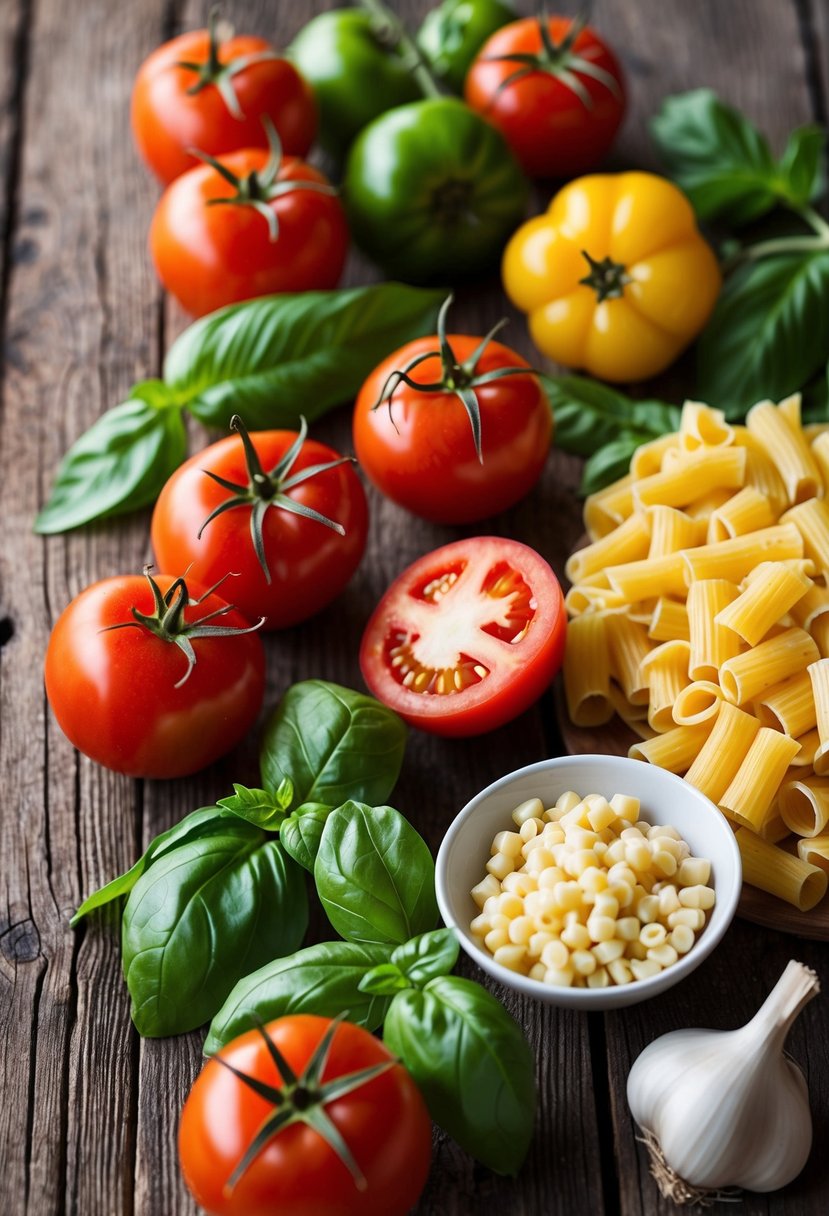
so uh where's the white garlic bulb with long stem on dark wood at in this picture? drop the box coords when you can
[627,961,820,1203]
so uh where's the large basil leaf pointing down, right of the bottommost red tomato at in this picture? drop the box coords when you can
[383,975,535,1173]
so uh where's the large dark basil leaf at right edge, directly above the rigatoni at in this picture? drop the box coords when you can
[698,253,829,418]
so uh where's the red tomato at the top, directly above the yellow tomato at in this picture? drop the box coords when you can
[466,17,625,178]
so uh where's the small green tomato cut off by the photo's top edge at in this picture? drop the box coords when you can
[417,0,518,94]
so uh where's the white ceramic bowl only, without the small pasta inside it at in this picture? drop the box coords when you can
[436,755,743,1009]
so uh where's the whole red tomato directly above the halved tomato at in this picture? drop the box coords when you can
[354,297,552,524]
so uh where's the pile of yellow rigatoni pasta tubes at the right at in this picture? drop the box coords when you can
[564,396,829,911]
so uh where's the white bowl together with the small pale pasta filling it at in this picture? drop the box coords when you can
[436,755,741,1009]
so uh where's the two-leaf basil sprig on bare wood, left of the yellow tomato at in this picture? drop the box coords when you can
[34,283,445,534]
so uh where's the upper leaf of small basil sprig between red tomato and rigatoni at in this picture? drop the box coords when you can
[540,376,681,466]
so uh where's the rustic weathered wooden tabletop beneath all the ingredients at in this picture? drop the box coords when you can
[0,0,829,1216]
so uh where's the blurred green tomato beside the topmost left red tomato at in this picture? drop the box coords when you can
[288,9,421,157]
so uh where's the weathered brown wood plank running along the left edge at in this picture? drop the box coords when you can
[0,0,163,1216]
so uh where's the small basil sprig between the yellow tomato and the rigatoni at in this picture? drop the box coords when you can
[541,376,679,494]
